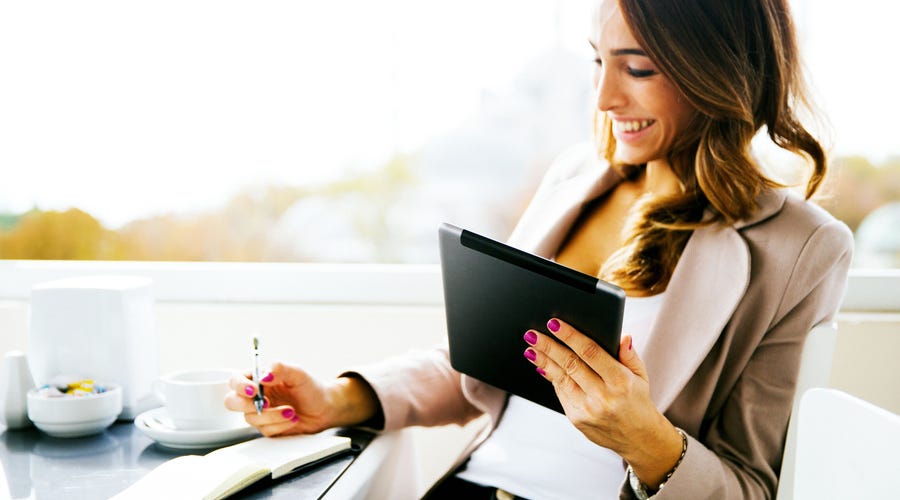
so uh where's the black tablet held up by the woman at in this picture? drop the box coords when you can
[439,224,625,413]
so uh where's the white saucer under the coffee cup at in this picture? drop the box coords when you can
[134,408,260,450]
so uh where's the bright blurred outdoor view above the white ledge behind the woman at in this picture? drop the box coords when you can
[0,0,900,266]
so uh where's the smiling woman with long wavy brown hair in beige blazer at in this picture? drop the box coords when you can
[226,0,852,499]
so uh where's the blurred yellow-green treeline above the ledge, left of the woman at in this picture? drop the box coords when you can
[0,157,412,262]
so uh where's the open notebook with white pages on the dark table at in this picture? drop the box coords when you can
[113,434,351,500]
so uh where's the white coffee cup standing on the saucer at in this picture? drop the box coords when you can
[153,369,243,430]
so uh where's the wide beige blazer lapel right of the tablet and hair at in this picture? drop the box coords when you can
[639,226,750,411]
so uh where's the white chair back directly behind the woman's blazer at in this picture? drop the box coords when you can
[777,321,837,500]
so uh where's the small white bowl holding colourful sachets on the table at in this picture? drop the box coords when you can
[28,385,122,437]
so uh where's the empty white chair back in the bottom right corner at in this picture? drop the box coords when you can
[793,388,900,500]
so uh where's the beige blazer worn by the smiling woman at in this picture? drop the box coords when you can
[355,150,852,500]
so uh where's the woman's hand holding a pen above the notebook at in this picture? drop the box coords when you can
[225,363,378,436]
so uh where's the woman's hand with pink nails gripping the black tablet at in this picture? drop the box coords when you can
[525,318,682,485]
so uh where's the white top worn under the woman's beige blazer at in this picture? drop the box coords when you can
[458,293,665,499]
